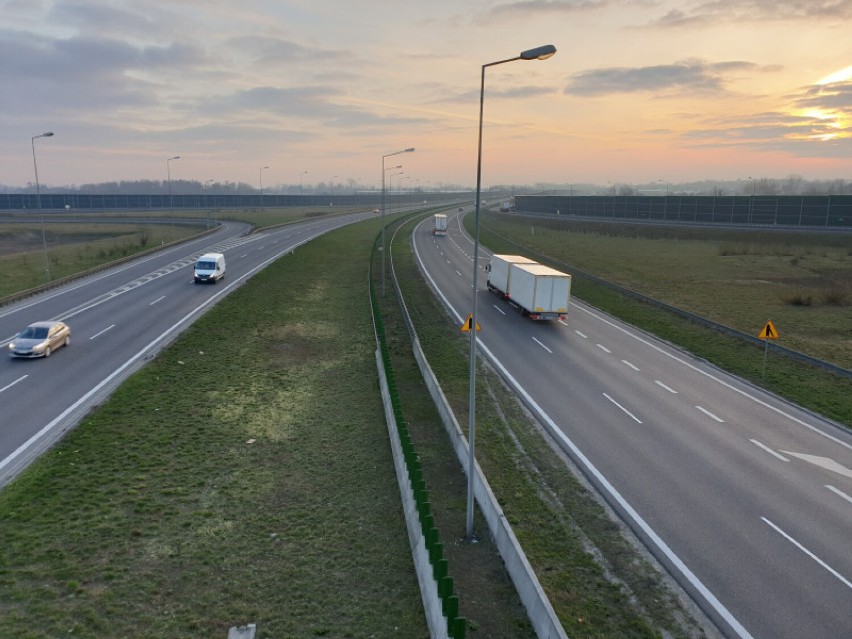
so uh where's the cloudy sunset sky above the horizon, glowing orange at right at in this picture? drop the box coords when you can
[0,0,852,189]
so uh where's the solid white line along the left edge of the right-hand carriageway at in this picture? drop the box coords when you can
[412,232,753,639]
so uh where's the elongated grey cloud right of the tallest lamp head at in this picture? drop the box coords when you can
[565,60,757,96]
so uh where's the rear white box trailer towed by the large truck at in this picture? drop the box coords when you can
[507,263,571,320]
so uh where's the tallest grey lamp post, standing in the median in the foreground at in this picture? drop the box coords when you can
[467,44,556,540]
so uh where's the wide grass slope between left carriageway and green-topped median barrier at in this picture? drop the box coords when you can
[0,222,427,638]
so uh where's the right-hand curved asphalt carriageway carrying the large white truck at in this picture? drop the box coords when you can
[414,208,852,639]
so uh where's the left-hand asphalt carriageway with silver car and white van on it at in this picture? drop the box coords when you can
[0,213,369,486]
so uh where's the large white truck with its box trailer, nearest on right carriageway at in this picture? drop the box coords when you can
[487,255,571,320]
